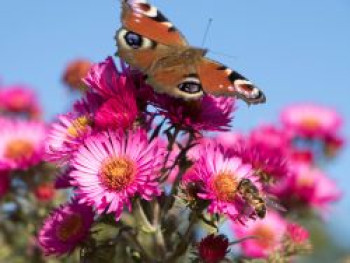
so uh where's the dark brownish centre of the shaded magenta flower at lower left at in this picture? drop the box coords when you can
[57,214,83,242]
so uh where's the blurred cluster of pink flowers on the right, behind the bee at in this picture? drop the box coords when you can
[216,104,343,262]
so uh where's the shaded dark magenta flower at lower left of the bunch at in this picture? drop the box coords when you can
[38,201,94,256]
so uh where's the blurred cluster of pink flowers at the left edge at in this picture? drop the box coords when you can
[0,86,47,199]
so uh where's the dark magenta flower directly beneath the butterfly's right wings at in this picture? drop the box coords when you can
[151,94,235,131]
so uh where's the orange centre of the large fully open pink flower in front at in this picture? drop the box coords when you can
[101,157,136,191]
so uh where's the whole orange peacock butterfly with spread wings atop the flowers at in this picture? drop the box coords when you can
[115,0,266,104]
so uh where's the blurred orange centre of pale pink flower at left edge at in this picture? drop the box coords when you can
[5,139,34,160]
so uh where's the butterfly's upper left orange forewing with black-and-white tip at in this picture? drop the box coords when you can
[122,0,188,46]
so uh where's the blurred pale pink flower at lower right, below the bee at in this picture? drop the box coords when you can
[232,211,287,258]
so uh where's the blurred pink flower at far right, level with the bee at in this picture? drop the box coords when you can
[289,163,341,212]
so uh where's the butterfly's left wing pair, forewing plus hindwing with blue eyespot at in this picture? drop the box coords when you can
[116,0,187,74]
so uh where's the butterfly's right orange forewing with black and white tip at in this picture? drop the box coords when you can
[197,58,265,104]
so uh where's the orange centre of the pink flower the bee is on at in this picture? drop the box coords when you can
[213,172,238,202]
